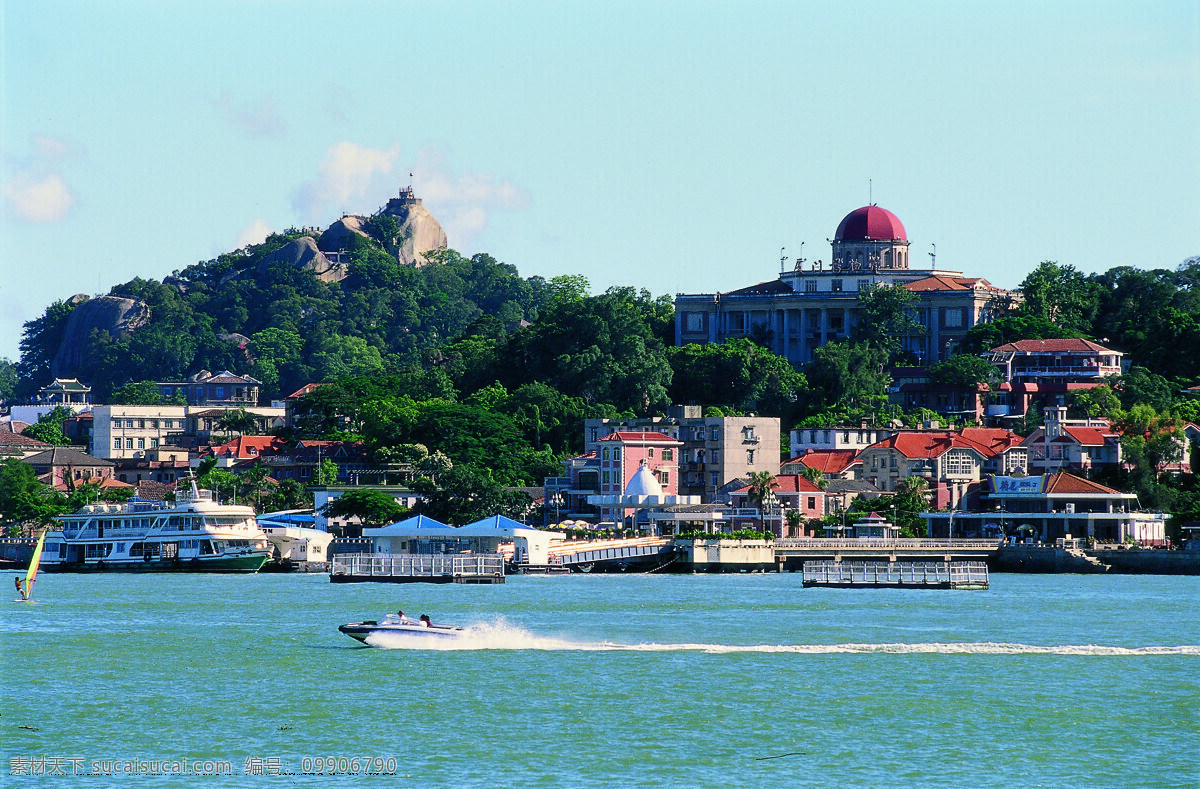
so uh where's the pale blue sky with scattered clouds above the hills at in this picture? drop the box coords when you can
[0,0,1200,361]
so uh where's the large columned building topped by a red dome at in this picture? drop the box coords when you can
[674,205,1015,365]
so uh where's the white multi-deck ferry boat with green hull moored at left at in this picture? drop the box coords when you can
[42,472,271,572]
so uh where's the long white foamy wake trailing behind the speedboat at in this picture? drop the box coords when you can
[357,621,1200,657]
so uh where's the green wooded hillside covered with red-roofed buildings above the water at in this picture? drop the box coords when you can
[0,195,1200,547]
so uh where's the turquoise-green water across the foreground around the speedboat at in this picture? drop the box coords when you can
[0,574,1200,787]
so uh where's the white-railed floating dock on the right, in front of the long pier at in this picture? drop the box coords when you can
[802,561,988,589]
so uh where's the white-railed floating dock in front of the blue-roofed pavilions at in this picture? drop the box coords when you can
[329,554,504,584]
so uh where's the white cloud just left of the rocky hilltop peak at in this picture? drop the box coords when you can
[292,140,401,223]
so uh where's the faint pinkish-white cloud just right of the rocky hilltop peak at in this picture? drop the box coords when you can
[413,149,529,252]
